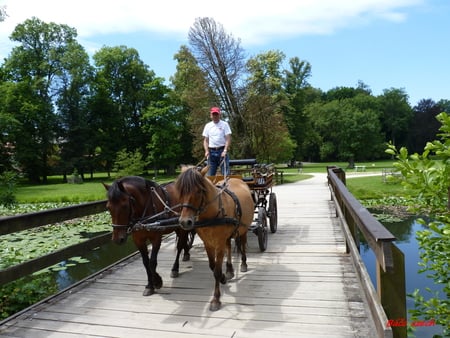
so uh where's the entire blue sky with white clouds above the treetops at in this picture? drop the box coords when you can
[0,0,450,106]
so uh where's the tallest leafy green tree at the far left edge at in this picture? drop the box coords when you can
[4,18,76,182]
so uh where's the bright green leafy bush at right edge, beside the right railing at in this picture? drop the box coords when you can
[386,113,450,335]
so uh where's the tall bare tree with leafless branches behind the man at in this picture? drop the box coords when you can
[188,17,245,153]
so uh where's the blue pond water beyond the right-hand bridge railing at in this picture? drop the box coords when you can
[360,217,442,338]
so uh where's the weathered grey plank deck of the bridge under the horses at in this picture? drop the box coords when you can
[0,174,400,338]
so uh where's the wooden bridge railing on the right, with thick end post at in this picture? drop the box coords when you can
[327,166,407,337]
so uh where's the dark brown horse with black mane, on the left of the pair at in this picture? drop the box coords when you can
[103,176,194,296]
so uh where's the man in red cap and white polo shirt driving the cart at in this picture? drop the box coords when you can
[202,107,231,176]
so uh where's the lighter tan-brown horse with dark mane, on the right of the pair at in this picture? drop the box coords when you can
[175,167,254,311]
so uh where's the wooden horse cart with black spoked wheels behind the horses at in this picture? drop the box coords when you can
[209,159,278,251]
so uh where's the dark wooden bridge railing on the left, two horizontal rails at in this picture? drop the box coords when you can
[0,200,111,286]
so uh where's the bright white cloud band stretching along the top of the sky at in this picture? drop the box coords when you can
[0,0,425,54]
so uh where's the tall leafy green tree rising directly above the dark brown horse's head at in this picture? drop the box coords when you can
[91,46,155,171]
